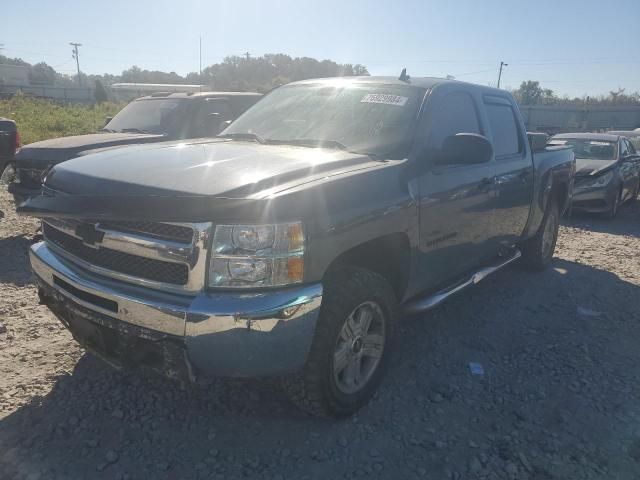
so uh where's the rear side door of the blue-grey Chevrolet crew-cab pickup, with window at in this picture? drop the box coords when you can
[483,96,533,247]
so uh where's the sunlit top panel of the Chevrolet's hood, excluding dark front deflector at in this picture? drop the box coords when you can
[44,140,380,199]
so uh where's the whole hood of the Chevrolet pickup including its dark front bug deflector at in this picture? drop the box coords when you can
[17,140,384,222]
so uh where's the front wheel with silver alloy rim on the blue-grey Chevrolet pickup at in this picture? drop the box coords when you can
[282,267,398,417]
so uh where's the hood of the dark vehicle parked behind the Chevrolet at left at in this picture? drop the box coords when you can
[16,132,164,169]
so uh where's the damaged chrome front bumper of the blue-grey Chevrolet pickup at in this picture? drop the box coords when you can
[30,242,322,376]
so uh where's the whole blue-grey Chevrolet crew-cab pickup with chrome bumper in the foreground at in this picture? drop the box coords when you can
[19,75,575,416]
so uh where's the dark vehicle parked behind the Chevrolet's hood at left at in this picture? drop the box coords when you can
[9,92,262,205]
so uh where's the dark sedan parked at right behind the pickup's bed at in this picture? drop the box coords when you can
[549,133,640,218]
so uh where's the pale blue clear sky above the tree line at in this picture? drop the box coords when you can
[0,0,640,97]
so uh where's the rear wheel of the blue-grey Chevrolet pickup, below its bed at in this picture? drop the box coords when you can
[520,198,560,270]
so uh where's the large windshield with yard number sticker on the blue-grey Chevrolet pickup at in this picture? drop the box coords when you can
[222,82,425,158]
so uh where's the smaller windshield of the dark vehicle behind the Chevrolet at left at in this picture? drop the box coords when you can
[104,98,186,135]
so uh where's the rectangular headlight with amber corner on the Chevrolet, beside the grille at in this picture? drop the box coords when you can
[208,223,304,287]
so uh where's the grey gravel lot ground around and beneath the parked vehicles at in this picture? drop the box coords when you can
[0,188,640,480]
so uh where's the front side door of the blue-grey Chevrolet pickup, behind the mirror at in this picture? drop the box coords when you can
[416,87,496,290]
